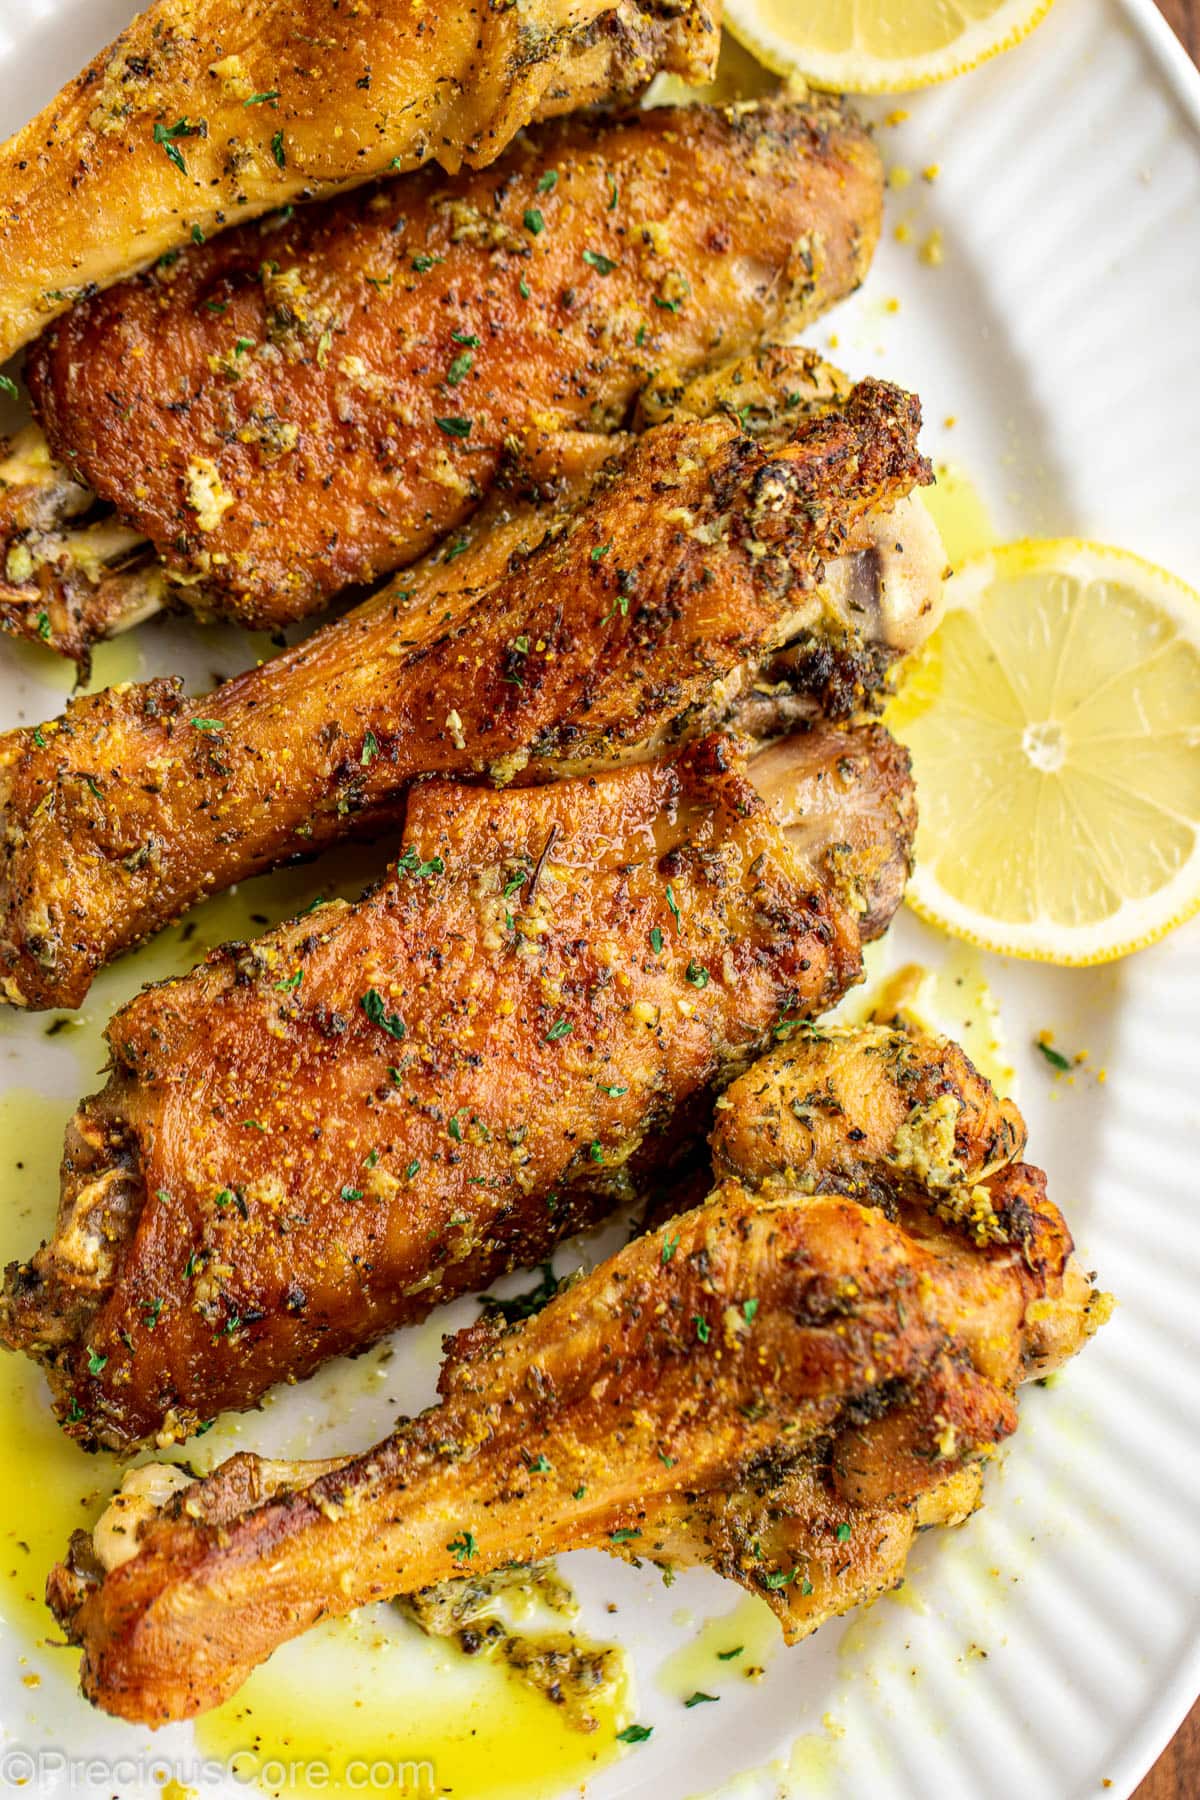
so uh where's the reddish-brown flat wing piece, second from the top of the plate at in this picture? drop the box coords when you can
[0,101,880,653]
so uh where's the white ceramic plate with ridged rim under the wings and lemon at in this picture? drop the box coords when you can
[0,0,1200,1800]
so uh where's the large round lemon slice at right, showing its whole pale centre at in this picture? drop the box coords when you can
[887,538,1200,963]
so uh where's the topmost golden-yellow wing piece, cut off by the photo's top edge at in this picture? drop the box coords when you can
[0,0,718,362]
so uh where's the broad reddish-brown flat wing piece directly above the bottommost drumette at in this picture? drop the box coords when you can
[4,725,914,1449]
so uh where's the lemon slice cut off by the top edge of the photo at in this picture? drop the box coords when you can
[725,0,1052,94]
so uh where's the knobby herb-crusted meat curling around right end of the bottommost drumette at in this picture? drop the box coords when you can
[711,1024,1106,1507]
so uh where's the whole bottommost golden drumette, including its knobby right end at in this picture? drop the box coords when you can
[49,1026,1105,1724]
